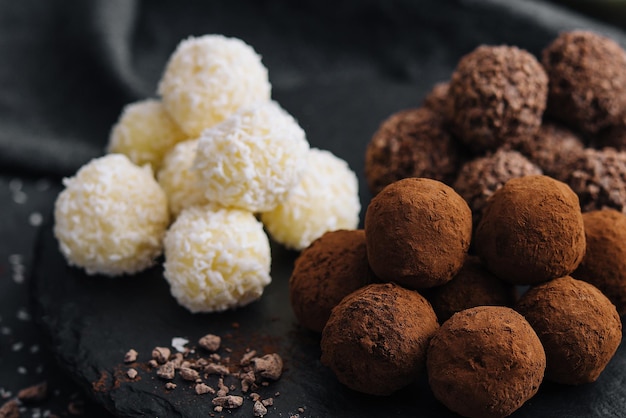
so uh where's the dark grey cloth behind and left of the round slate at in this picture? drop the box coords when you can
[0,0,626,417]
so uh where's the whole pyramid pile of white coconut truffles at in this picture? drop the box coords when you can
[54,35,361,312]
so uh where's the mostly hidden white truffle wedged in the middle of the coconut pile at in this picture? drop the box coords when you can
[157,139,209,217]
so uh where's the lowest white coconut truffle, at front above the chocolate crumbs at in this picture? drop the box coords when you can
[164,204,271,313]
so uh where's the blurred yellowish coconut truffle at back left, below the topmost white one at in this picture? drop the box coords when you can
[107,99,187,171]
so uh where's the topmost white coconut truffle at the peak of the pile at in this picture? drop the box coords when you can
[158,35,271,138]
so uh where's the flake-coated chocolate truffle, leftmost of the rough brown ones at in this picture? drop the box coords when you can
[365,107,463,195]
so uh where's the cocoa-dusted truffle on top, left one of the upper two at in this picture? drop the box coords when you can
[365,178,472,288]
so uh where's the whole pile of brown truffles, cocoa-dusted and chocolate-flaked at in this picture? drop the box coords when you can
[289,31,626,418]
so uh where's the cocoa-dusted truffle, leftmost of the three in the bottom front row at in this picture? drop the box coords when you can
[321,283,439,395]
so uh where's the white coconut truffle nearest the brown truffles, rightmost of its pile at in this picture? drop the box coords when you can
[261,148,361,250]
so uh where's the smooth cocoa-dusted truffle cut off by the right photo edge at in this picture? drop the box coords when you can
[572,209,626,315]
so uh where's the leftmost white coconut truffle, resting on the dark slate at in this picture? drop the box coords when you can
[54,154,169,276]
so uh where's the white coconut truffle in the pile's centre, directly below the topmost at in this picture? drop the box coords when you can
[194,101,309,212]
